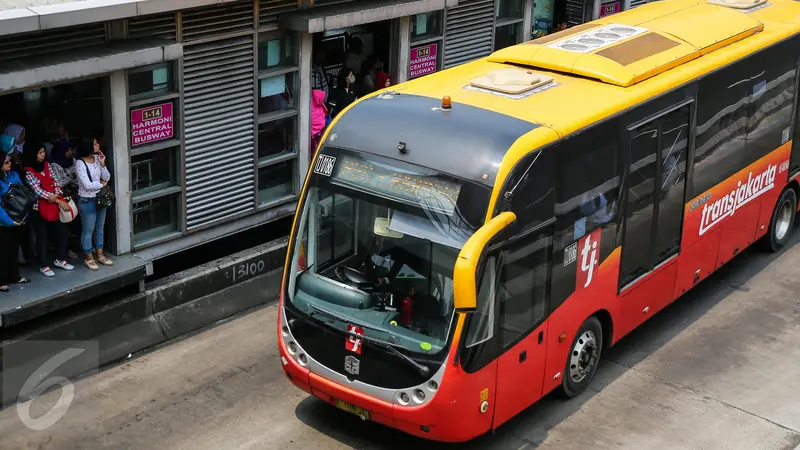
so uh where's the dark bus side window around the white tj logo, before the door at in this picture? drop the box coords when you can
[550,120,619,310]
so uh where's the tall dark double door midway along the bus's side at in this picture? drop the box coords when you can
[619,102,692,333]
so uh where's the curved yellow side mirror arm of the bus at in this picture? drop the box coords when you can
[453,211,517,312]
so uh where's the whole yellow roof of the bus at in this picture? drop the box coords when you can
[395,0,800,142]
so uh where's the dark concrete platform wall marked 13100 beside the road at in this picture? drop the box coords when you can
[0,239,286,408]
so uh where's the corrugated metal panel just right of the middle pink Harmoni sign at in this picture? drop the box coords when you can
[443,0,495,69]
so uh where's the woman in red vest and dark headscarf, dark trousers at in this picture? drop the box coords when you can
[22,143,74,277]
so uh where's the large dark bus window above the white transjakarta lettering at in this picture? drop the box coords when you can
[693,41,797,196]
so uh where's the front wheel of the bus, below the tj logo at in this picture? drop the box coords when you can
[561,316,604,398]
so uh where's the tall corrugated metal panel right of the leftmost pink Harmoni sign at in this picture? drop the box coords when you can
[183,1,256,231]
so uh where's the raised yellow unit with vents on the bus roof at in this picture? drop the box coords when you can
[489,0,764,87]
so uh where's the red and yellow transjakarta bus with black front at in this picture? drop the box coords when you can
[278,0,800,441]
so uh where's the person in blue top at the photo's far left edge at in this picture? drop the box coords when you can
[0,154,30,292]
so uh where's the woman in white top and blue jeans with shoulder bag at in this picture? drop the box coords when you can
[75,139,114,270]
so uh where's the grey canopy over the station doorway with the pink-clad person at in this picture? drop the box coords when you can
[278,0,458,33]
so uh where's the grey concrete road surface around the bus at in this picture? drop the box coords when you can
[0,230,800,450]
